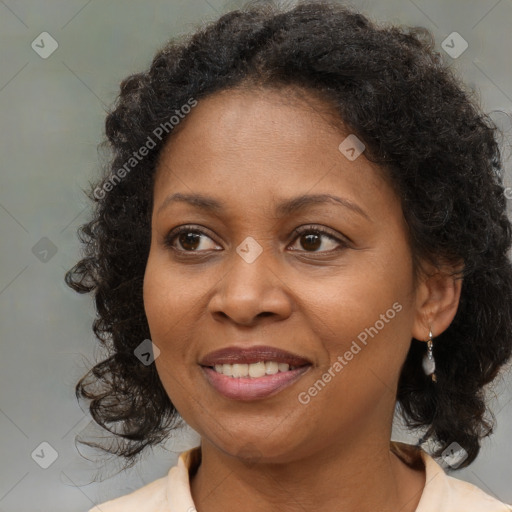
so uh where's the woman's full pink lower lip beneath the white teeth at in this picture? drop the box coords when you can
[202,365,310,400]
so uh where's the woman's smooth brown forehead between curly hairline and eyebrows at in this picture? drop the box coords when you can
[154,84,396,218]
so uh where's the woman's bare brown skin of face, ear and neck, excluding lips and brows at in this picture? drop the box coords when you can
[144,89,461,512]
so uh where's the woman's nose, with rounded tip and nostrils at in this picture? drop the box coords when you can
[209,242,293,326]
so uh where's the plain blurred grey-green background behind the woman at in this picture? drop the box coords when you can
[0,0,512,512]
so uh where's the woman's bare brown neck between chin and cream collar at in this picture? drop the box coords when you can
[191,434,425,512]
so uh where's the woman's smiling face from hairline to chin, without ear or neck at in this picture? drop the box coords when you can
[144,86,428,462]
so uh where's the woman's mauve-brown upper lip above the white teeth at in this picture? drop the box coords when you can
[199,345,311,366]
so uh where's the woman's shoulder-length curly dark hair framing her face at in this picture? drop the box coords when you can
[65,1,512,469]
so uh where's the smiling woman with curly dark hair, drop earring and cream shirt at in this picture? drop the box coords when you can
[66,2,512,512]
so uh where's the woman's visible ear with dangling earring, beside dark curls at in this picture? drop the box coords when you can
[411,265,462,341]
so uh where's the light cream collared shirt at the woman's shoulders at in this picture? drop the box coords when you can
[89,441,512,512]
